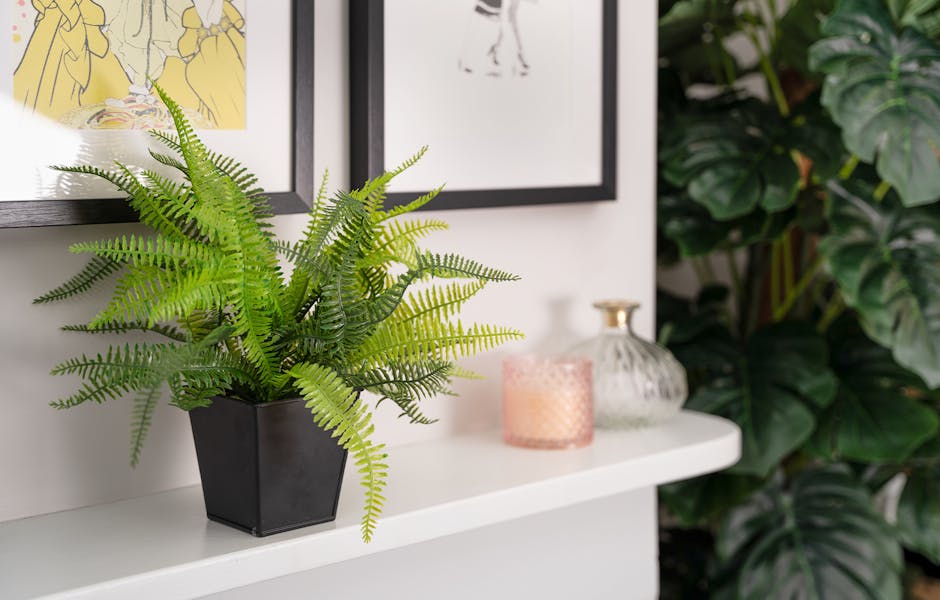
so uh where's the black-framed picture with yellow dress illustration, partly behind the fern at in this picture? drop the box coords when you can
[0,0,314,227]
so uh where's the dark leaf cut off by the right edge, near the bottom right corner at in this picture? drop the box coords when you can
[897,465,940,564]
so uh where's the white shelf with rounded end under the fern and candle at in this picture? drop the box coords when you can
[0,411,740,600]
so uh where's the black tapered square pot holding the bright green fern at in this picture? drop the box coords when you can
[189,397,346,537]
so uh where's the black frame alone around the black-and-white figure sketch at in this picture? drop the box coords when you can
[349,0,617,210]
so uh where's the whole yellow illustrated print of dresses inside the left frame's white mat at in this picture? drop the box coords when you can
[13,0,245,129]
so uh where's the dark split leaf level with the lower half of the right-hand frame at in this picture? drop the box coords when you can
[659,99,841,221]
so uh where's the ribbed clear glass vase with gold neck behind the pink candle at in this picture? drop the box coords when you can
[568,300,688,429]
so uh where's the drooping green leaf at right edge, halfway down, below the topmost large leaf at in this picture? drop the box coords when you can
[819,181,940,387]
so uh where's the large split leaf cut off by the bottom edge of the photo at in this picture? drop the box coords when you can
[718,466,902,600]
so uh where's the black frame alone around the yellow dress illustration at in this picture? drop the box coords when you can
[0,0,314,228]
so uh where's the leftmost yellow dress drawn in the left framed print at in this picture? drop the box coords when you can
[13,0,128,119]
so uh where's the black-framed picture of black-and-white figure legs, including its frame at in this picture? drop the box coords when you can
[350,0,617,209]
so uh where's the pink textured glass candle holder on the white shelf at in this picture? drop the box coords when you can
[503,355,594,448]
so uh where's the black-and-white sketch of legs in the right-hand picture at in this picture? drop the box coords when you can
[458,0,529,77]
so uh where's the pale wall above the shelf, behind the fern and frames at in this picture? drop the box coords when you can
[0,0,656,521]
